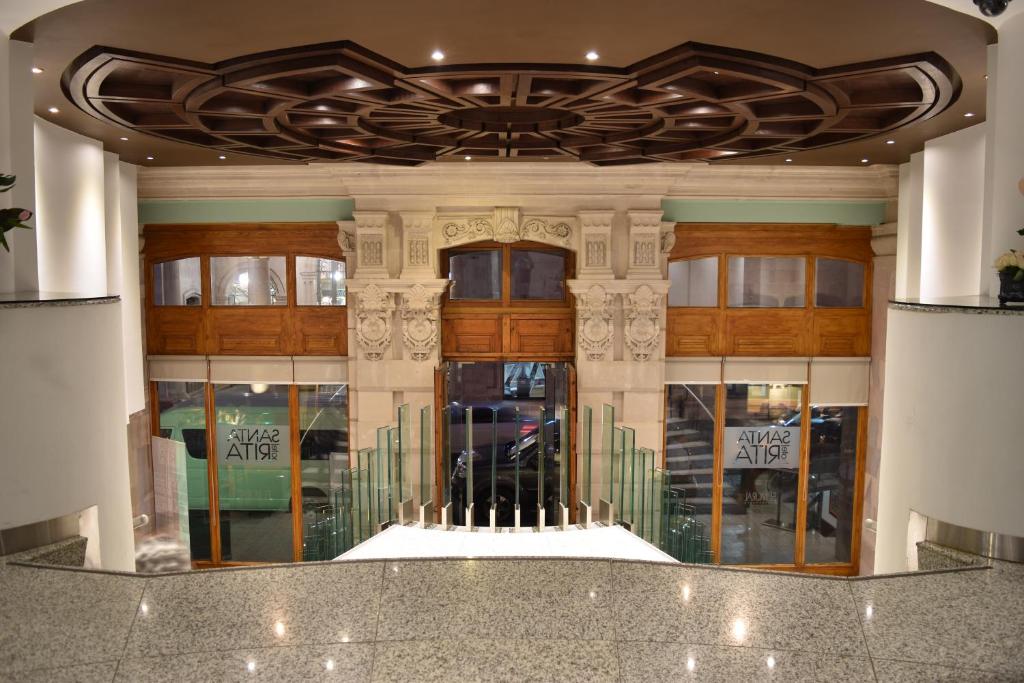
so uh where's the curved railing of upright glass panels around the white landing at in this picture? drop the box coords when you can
[303,404,712,562]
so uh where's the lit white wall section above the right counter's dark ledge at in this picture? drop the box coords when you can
[921,124,986,297]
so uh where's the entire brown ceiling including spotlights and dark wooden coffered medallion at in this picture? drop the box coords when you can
[14,0,994,165]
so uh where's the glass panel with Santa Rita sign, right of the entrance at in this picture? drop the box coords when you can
[720,384,803,564]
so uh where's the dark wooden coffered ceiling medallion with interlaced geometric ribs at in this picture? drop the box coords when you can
[62,42,962,166]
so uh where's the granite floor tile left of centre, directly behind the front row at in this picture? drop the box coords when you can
[126,562,383,657]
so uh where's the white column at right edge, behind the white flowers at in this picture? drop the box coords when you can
[982,13,1024,296]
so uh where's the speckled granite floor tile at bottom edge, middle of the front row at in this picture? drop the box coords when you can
[373,638,618,683]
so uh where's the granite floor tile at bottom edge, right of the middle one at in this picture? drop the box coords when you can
[618,642,874,683]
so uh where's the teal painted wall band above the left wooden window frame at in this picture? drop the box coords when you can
[138,199,355,225]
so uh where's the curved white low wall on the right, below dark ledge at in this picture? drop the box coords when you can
[874,309,1024,572]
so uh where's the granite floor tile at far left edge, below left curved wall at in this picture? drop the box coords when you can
[0,566,146,673]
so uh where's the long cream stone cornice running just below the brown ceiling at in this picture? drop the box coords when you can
[138,162,898,202]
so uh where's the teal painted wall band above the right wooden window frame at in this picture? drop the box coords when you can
[662,199,886,225]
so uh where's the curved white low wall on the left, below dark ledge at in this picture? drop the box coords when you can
[0,303,134,570]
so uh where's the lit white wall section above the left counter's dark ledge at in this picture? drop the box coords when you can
[35,118,108,295]
